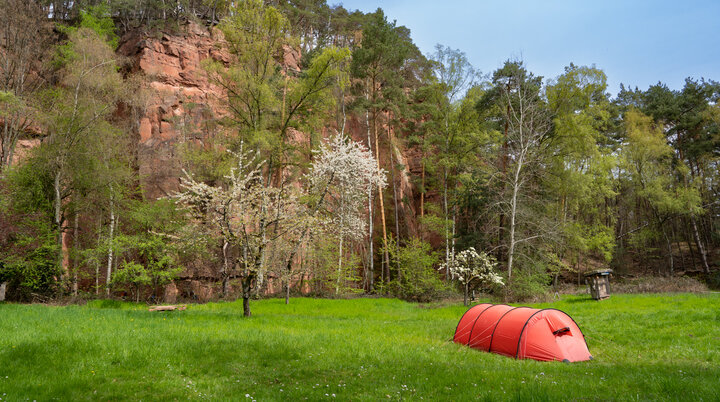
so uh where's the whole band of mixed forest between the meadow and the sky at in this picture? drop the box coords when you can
[0,0,720,310]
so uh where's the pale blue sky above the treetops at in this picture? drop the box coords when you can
[338,0,720,94]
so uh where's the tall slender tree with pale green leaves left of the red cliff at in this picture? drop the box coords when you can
[25,20,134,288]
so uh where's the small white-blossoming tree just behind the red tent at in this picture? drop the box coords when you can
[440,247,504,306]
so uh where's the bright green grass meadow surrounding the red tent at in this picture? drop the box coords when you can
[0,294,720,401]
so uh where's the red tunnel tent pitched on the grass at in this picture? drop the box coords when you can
[453,303,592,362]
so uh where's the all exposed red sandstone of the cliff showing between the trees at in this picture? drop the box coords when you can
[118,23,420,236]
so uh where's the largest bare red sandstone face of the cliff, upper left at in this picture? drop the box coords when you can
[118,23,230,199]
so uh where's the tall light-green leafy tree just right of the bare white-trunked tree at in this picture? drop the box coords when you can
[543,64,617,279]
